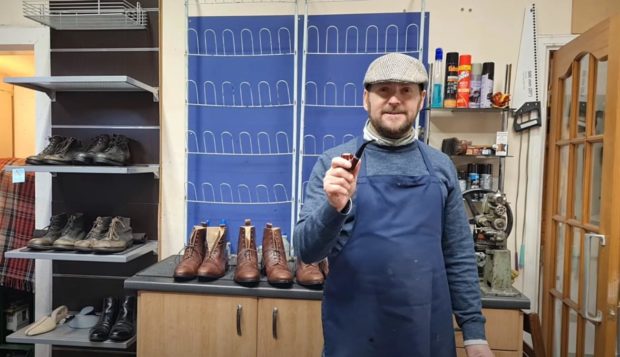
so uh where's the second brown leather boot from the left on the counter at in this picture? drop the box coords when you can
[198,224,228,280]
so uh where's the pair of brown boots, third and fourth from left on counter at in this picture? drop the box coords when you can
[234,219,293,284]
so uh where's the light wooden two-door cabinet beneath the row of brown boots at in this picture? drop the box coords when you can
[138,292,323,357]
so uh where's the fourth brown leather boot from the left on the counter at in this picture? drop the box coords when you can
[263,223,293,284]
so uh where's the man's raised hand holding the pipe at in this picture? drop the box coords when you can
[323,157,362,212]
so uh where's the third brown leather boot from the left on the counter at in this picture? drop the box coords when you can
[234,219,260,284]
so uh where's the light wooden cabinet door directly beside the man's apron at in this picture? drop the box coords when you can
[257,299,323,357]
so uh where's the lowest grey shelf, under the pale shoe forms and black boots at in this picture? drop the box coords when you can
[6,324,136,349]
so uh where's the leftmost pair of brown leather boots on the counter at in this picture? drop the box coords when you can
[174,223,228,281]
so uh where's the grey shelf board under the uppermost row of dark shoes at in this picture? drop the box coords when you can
[4,164,159,179]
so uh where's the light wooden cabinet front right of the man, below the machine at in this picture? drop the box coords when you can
[454,309,523,357]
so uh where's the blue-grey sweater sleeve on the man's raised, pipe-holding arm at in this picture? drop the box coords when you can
[294,155,352,263]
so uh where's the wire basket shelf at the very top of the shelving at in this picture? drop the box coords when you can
[23,0,147,30]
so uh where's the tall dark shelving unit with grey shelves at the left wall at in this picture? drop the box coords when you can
[4,0,161,357]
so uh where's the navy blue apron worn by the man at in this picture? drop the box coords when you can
[322,138,456,357]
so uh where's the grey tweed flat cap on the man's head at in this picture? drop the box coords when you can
[364,53,428,86]
